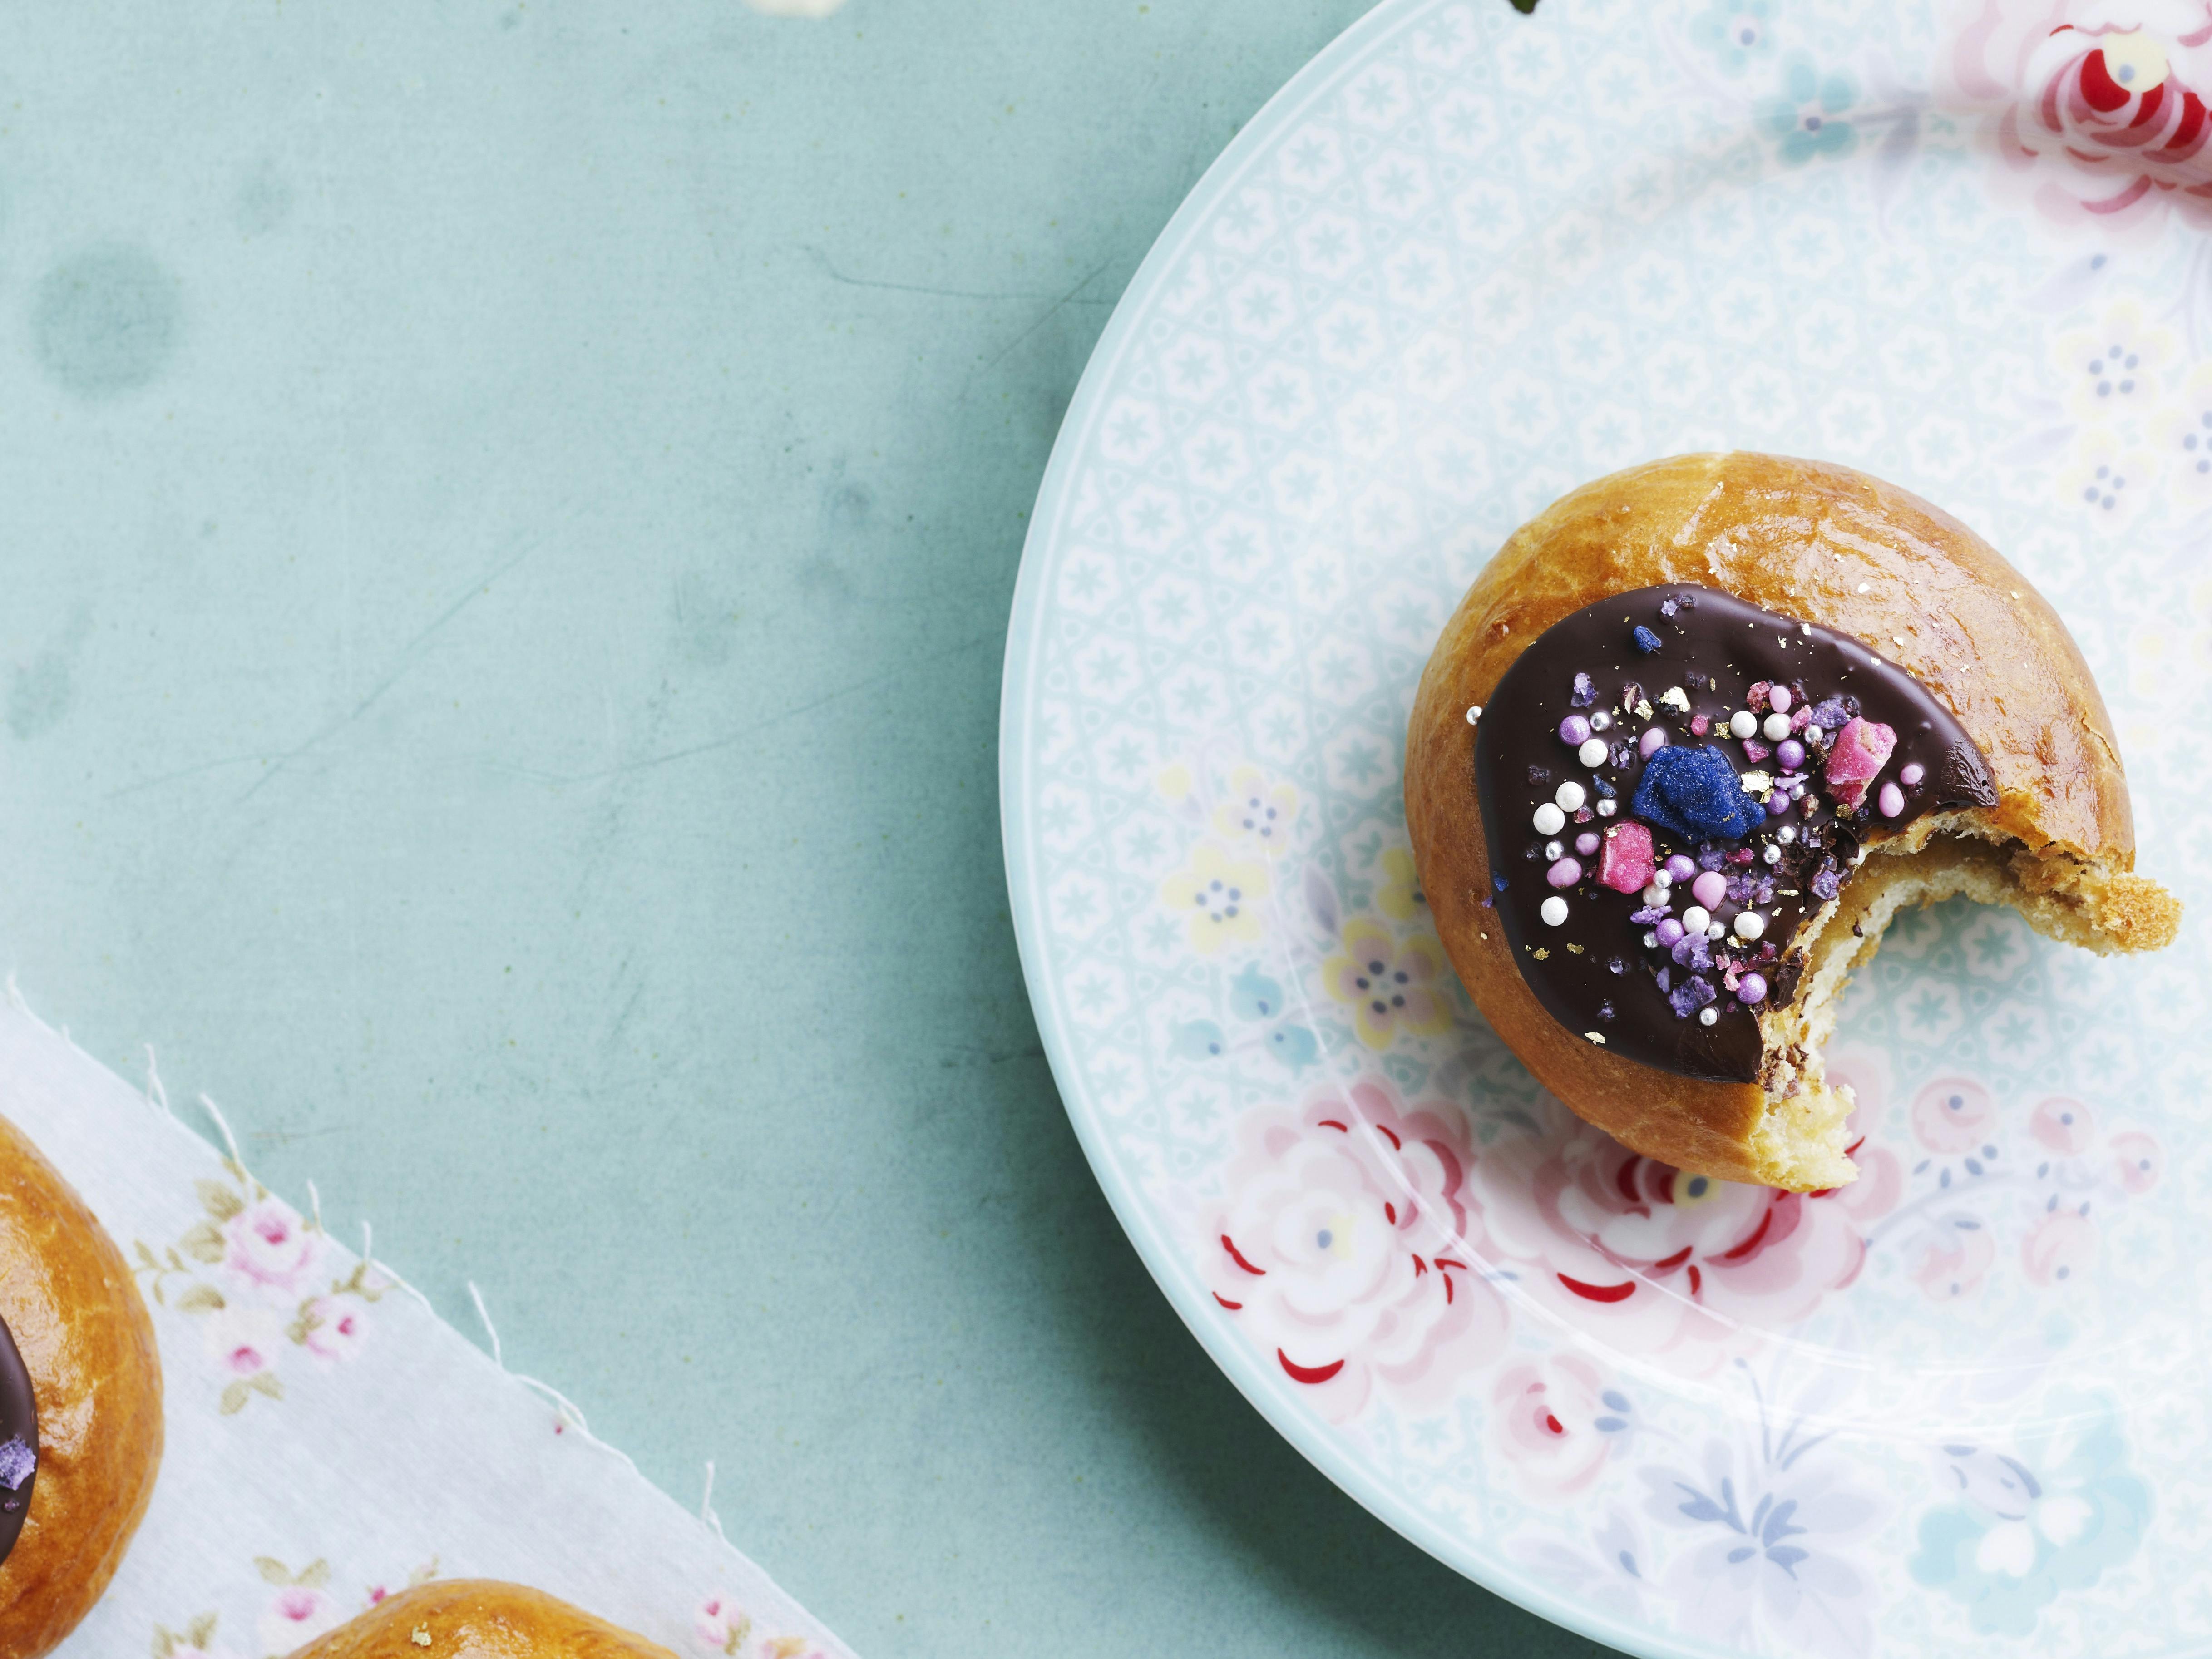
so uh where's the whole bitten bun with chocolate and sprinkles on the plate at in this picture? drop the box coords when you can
[1405,454,2181,1192]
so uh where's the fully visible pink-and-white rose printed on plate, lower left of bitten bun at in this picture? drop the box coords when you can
[1201,1080,1506,1422]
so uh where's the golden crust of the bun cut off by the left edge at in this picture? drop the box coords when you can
[0,1119,162,1659]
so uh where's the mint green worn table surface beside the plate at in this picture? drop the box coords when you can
[0,0,1590,1659]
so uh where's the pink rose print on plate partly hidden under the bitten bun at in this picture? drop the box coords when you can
[1469,1092,1898,1369]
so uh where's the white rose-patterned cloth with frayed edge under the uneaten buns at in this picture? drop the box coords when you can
[0,1007,849,1659]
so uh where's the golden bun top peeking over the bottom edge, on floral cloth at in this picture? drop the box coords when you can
[292,1580,675,1659]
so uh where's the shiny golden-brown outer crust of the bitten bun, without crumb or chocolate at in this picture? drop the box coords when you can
[1405,454,2172,1181]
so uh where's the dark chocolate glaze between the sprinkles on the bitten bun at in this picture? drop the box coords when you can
[1473,586,1997,1084]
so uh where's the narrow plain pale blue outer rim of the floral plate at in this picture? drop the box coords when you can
[997,0,1728,1659]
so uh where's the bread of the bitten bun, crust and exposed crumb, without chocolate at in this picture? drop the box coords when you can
[1405,454,2181,1190]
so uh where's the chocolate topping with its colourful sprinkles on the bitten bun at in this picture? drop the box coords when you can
[1473,586,1997,1084]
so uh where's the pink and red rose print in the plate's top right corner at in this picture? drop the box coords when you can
[1949,0,2212,228]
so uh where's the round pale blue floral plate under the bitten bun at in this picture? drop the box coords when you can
[1002,0,2212,1654]
